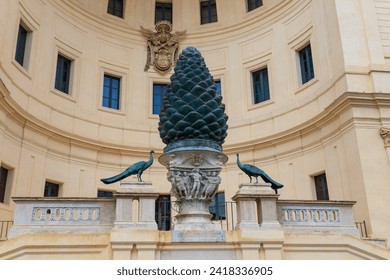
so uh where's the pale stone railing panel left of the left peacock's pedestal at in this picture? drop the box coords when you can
[9,197,116,236]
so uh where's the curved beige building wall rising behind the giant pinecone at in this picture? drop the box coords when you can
[0,0,390,247]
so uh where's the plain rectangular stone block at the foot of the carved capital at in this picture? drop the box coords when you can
[172,230,226,242]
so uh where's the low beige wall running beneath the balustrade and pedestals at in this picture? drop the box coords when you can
[0,231,390,260]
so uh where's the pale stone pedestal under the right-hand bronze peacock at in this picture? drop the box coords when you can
[232,183,280,230]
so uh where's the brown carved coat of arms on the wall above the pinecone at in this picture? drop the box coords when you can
[141,21,187,74]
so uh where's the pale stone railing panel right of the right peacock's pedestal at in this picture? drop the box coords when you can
[277,200,359,236]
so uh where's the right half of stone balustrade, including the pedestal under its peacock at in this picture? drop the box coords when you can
[233,184,359,236]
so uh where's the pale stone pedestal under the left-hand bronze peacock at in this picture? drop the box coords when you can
[114,182,159,230]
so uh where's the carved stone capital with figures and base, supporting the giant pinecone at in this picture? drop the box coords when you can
[159,147,227,242]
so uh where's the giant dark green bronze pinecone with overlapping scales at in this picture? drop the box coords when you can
[158,47,228,149]
